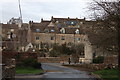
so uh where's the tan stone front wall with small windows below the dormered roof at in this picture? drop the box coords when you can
[31,33,84,44]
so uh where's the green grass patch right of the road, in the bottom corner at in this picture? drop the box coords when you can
[93,69,118,80]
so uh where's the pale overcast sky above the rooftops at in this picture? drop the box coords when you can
[0,0,92,23]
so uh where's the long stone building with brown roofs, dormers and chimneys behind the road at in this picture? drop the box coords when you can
[2,16,92,63]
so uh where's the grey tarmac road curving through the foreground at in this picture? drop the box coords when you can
[16,63,98,80]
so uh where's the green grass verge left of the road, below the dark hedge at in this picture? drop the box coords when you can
[16,67,44,74]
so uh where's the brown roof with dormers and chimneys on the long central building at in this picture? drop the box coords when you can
[31,17,85,34]
